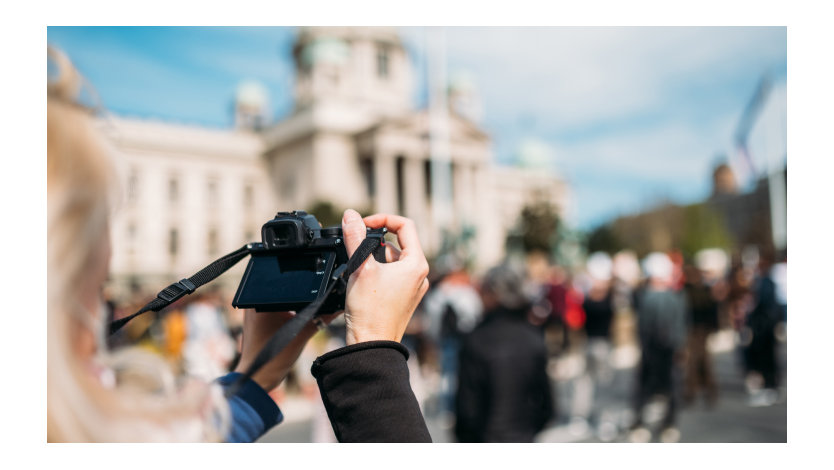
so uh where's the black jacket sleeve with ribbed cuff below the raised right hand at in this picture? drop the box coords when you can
[312,341,431,442]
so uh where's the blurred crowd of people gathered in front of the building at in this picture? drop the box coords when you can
[105,242,787,442]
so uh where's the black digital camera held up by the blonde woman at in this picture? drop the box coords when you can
[232,211,385,314]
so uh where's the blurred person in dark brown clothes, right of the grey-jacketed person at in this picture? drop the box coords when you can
[683,264,718,406]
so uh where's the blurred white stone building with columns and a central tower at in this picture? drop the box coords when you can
[102,27,568,300]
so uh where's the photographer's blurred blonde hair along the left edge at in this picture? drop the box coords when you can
[47,48,229,442]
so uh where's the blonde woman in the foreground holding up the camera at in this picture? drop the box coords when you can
[47,48,431,442]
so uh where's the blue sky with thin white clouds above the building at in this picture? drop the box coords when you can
[47,27,787,228]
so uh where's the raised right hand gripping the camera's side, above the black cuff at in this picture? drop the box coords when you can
[342,209,429,345]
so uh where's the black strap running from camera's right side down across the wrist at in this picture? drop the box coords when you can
[225,235,385,398]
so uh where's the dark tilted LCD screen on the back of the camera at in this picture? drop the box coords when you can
[234,252,335,310]
